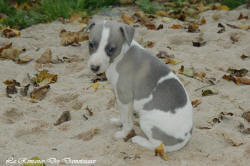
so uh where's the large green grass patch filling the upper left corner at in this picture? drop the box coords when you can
[0,0,119,29]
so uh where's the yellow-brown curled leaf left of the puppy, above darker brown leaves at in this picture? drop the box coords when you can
[31,70,57,85]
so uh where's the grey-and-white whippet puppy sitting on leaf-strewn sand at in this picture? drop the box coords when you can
[85,20,193,152]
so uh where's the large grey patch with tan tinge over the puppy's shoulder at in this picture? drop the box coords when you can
[116,46,170,104]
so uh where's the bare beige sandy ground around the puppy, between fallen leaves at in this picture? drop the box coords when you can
[0,4,250,166]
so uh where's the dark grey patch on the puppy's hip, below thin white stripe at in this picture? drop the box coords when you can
[143,78,187,113]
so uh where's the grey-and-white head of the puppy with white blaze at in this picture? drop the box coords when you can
[85,20,134,73]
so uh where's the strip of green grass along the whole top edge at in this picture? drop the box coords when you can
[0,0,249,29]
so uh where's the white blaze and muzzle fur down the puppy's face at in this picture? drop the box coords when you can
[88,21,110,73]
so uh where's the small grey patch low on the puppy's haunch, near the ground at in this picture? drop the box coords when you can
[151,126,184,146]
